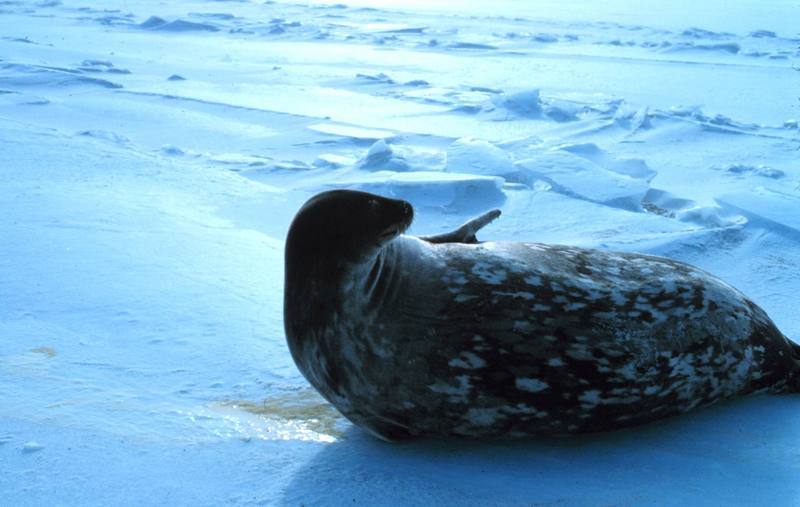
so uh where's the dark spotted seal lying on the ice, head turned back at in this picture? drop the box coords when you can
[284,190,800,440]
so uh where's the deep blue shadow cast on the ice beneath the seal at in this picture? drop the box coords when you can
[279,395,800,506]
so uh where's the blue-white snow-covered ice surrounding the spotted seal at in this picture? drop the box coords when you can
[0,0,800,506]
